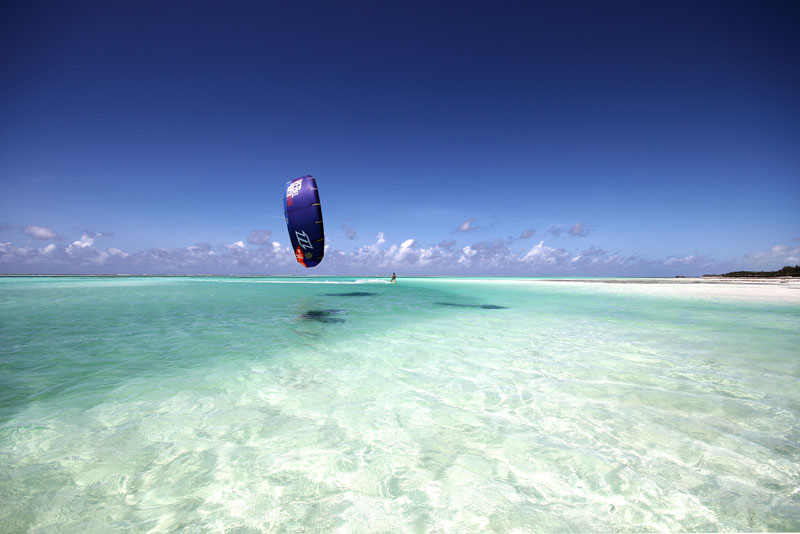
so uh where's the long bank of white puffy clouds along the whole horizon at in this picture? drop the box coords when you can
[0,225,800,276]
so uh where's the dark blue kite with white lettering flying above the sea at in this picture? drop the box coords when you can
[283,174,325,267]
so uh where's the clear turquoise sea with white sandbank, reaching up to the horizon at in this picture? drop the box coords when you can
[0,278,800,533]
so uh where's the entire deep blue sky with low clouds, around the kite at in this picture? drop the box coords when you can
[0,2,800,276]
